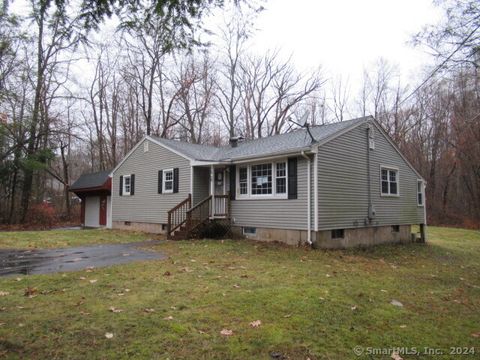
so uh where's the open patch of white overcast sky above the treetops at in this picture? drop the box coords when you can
[232,0,440,87]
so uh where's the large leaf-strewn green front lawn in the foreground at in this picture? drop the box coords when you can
[0,228,480,359]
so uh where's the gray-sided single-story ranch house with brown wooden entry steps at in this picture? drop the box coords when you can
[74,117,426,248]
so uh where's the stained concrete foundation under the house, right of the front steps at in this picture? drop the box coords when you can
[232,225,412,249]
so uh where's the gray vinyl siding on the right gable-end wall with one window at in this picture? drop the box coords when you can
[318,120,424,230]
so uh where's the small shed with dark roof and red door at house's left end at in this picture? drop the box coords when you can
[70,170,112,228]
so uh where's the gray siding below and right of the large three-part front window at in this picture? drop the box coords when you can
[231,157,313,230]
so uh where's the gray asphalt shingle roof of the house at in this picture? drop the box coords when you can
[152,116,371,161]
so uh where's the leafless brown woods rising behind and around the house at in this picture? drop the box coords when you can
[0,0,480,228]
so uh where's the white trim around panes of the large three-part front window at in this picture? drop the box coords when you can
[235,158,288,200]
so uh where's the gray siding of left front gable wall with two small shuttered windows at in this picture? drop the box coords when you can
[112,140,190,224]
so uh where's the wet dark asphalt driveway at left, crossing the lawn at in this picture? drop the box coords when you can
[0,240,166,276]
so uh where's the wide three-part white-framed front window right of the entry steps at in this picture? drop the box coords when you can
[237,161,288,199]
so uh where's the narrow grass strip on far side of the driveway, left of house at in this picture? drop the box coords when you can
[0,229,152,249]
